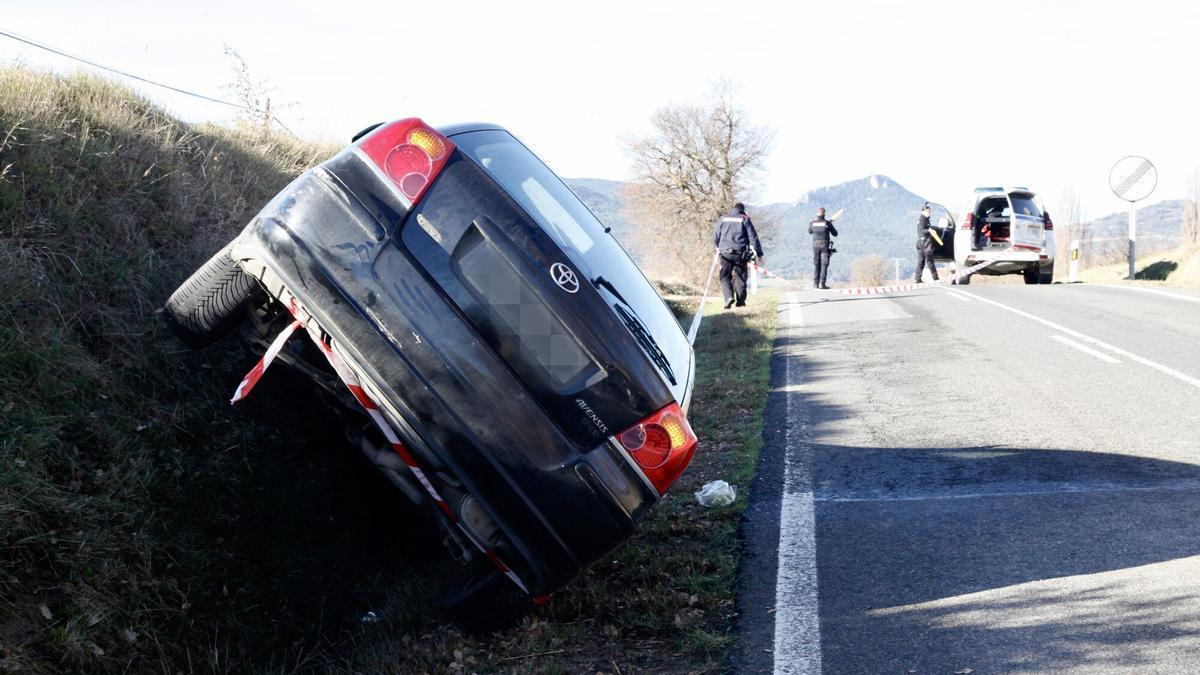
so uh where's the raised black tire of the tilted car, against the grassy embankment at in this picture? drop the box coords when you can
[163,244,256,350]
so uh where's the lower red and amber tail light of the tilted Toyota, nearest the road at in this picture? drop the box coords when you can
[617,404,696,495]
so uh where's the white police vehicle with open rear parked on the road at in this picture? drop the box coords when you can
[938,186,1055,283]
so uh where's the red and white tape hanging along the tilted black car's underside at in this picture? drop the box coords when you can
[229,288,548,595]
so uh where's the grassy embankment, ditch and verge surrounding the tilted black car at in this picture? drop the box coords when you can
[0,68,774,673]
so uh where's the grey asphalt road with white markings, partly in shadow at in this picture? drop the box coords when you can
[736,285,1200,674]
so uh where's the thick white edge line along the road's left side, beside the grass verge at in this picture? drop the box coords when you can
[774,293,821,674]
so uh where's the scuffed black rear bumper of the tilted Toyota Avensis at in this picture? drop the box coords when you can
[233,159,658,596]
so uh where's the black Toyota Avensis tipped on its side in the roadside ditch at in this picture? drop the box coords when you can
[166,118,696,607]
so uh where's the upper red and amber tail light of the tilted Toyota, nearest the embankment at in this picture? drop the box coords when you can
[359,118,455,204]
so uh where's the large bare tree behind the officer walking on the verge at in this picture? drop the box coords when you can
[626,80,774,281]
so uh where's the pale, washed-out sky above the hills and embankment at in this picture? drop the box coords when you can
[0,0,1200,216]
